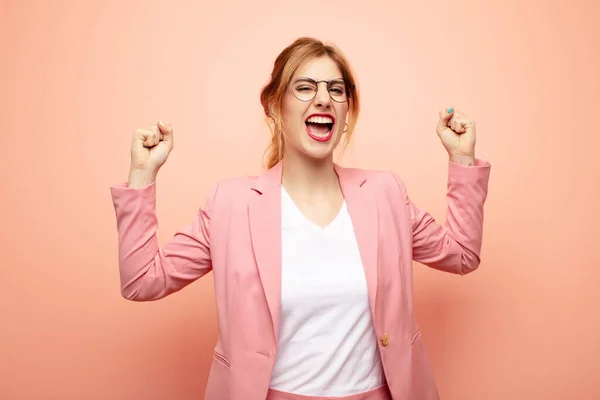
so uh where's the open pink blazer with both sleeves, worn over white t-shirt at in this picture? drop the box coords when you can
[111,160,490,400]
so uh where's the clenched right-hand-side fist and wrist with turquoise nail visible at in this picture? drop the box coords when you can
[436,108,475,165]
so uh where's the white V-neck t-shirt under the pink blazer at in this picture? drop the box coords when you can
[271,186,385,396]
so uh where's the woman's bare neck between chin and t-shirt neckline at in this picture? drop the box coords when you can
[281,155,340,197]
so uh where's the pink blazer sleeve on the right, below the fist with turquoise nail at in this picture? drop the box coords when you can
[394,159,491,275]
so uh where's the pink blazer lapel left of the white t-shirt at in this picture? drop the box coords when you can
[248,162,282,343]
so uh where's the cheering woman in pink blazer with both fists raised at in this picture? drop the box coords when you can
[111,38,490,400]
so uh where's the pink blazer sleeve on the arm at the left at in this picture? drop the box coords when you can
[110,182,218,301]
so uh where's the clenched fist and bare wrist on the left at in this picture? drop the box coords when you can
[129,121,173,187]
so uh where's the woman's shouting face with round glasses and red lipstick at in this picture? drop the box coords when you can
[282,57,348,160]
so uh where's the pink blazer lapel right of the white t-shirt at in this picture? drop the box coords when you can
[334,164,379,318]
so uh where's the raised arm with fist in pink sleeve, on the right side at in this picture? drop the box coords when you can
[396,108,491,275]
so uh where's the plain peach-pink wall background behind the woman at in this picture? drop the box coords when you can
[0,0,600,400]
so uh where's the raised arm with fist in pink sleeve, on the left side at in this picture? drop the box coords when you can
[110,123,218,301]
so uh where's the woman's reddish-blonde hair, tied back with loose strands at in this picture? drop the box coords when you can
[260,37,360,168]
